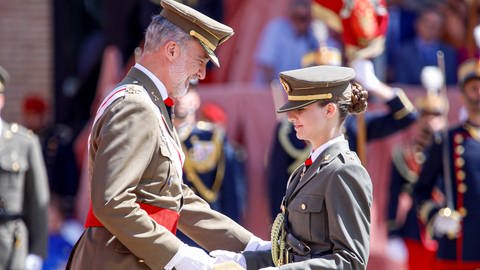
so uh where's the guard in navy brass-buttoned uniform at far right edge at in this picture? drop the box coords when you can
[414,59,480,270]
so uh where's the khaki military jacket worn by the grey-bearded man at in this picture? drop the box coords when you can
[70,68,251,270]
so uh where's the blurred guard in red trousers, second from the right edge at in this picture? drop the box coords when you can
[387,92,446,270]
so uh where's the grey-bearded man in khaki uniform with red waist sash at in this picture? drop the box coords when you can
[67,0,268,270]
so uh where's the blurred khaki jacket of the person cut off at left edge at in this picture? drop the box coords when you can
[0,119,49,269]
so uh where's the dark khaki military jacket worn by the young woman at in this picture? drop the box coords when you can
[244,141,372,270]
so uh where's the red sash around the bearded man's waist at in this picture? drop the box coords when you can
[85,203,180,234]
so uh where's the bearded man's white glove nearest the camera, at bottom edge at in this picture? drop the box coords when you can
[165,244,215,270]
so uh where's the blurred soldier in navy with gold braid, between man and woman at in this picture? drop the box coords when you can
[174,84,245,245]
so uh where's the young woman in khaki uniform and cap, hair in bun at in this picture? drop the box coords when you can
[211,66,372,269]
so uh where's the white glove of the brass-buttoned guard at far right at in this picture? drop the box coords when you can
[433,208,461,238]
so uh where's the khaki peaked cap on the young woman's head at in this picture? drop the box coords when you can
[277,66,355,113]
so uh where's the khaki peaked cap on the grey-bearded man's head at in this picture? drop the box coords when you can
[160,0,234,67]
